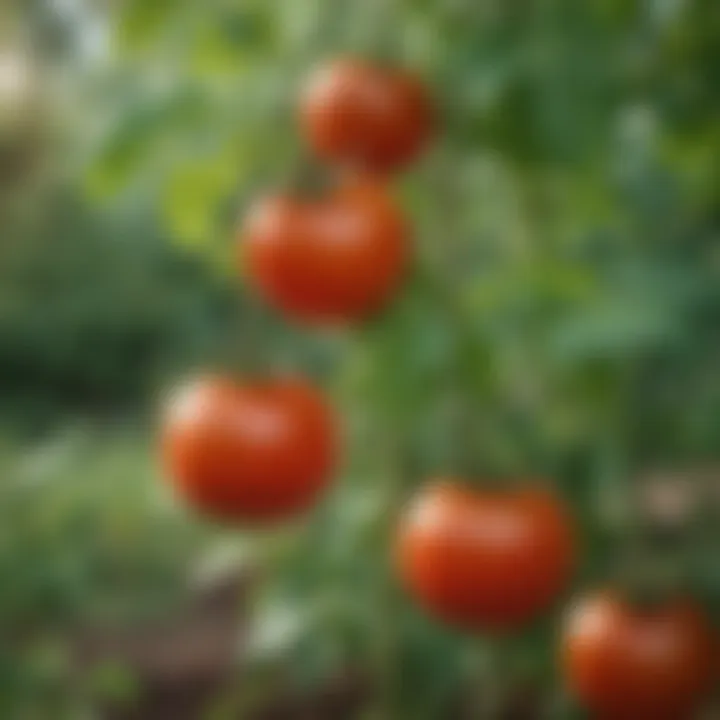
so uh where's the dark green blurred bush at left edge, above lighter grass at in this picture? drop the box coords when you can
[0,192,236,430]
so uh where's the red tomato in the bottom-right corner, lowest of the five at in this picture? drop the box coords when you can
[563,592,715,720]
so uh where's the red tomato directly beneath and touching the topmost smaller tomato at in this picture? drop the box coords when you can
[239,182,408,322]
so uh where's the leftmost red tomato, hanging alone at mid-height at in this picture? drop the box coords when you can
[162,377,336,522]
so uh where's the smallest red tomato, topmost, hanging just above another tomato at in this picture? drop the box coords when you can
[300,59,433,173]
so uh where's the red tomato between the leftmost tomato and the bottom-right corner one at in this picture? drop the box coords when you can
[397,481,574,631]
